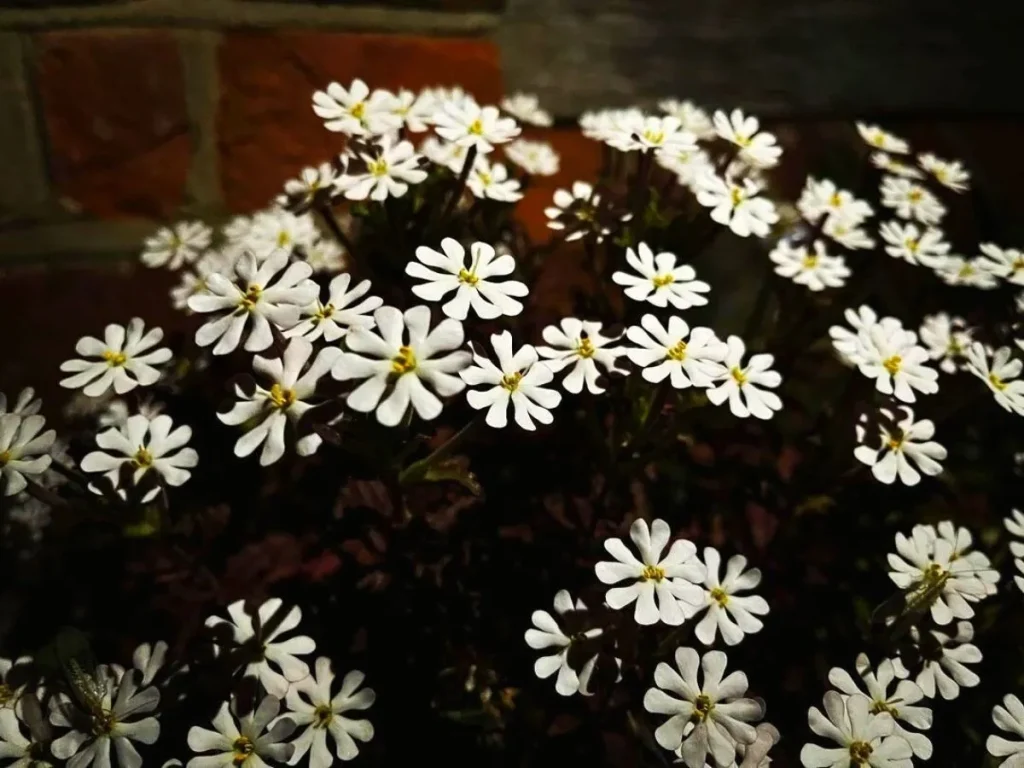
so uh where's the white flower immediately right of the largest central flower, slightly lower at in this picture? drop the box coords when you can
[459,331,562,430]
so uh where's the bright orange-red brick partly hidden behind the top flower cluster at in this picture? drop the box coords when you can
[218,32,502,211]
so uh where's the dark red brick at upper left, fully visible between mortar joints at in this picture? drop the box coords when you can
[37,30,189,217]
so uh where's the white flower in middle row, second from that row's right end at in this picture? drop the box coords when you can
[626,314,728,389]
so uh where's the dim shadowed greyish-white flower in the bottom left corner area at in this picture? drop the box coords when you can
[50,668,160,768]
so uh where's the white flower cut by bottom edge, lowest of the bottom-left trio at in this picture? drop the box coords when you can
[188,694,295,768]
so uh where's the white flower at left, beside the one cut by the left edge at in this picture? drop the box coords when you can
[82,414,199,503]
